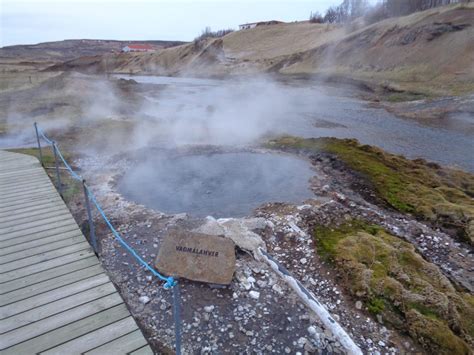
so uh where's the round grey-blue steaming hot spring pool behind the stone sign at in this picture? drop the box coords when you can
[117,152,315,217]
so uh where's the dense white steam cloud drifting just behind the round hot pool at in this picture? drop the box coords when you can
[128,78,324,150]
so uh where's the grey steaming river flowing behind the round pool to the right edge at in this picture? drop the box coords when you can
[118,76,474,171]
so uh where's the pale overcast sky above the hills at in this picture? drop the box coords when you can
[0,0,360,47]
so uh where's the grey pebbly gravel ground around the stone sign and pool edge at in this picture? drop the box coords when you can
[63,147,473,354]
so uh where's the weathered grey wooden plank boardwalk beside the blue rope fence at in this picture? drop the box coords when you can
[0,151,153,354]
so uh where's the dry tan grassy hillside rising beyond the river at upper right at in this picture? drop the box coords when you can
[55,3,474,95]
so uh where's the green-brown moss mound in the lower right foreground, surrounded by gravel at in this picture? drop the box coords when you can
[314,220,474,354]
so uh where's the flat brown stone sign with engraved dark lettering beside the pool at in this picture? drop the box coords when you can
[155,230,235,285]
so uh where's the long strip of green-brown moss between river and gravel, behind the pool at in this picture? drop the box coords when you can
[267,137,474,242]
